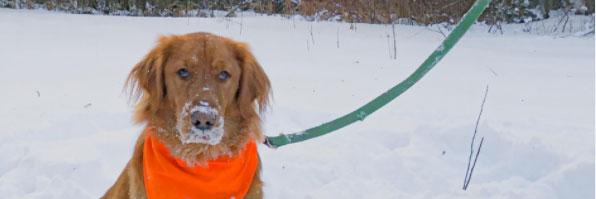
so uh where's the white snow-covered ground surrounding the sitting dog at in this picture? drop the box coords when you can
[0,9,595,199]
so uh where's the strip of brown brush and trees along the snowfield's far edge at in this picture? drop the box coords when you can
[0,0,594,25]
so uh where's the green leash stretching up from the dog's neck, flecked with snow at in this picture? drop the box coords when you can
[265,0,491,148]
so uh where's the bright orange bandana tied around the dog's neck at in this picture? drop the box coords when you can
[143,128,259,199]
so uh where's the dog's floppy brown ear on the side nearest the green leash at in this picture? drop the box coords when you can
[232,42,271,137]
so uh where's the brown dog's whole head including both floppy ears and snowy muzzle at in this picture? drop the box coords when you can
[127,33,270,146]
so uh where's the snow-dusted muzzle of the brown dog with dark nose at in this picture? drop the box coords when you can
[176,103,224,145]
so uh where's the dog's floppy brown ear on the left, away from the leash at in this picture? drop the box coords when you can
[125,36,173,122]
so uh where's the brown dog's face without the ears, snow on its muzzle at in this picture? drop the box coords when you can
[164,37,242,145]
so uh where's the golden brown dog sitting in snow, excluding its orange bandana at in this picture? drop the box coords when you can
[103,33,270,198]
